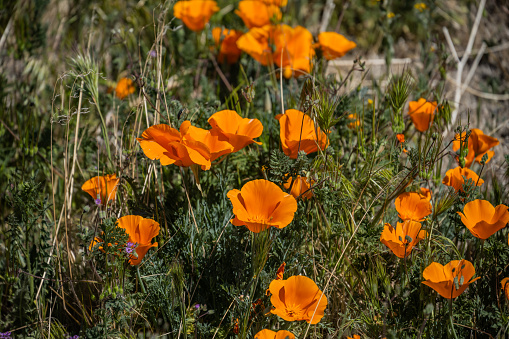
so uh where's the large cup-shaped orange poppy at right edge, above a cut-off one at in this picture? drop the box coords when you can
[457,199,509,239]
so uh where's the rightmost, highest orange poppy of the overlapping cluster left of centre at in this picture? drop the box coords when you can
[208,110,263,152]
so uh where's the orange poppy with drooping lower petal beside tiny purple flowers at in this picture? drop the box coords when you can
[117,215,160,266]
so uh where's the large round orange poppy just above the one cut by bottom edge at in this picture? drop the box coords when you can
[269,275,327,324]
